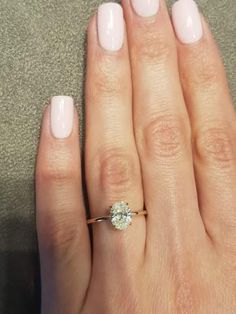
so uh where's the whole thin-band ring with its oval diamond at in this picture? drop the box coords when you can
[87,201,147,230]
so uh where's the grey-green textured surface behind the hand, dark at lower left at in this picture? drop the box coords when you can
[0,0,236,314]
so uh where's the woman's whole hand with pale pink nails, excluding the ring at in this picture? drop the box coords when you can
[36,0,236,314]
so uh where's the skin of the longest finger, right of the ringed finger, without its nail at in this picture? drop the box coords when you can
[122,0,205,262]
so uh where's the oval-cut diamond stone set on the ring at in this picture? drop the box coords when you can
[110,201,132,230]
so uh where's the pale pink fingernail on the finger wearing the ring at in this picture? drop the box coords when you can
[97,2,124,51]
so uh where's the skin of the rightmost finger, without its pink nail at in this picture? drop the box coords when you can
[173,11,236,251]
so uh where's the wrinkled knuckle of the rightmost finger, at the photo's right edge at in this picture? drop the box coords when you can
[195,126,235,168]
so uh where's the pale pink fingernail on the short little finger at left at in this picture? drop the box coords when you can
[51,96,74,138]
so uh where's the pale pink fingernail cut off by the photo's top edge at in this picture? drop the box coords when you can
[132,0,159,17]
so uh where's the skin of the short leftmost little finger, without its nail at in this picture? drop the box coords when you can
[36,105,91,314]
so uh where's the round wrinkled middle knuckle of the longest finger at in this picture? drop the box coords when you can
[143,115,187,158]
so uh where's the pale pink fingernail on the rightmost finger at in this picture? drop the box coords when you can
[172,0,203,44]
